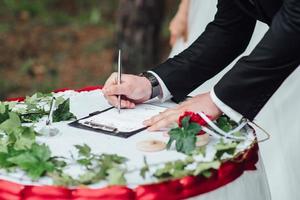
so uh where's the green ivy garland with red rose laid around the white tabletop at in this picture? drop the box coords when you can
[0,93,255,186]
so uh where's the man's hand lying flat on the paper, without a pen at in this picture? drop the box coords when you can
[144,92,222,131]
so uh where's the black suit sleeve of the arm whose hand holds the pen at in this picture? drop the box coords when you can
[153,0,256,102]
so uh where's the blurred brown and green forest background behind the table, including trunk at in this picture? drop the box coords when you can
[0,0,179,100]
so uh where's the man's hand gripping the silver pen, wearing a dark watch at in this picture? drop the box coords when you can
[102,73,152,108]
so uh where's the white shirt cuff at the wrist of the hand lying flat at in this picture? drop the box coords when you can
[210,89,243,123]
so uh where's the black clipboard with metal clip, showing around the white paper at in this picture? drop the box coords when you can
[68,107,147,138]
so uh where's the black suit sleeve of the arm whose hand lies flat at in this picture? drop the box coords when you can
[214,0,300,120]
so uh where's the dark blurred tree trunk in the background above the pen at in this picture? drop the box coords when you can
[117,0,164,74]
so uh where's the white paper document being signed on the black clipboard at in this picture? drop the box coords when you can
[79,104,166,132]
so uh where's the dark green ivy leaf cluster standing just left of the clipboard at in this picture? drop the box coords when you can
[53,99,76,122]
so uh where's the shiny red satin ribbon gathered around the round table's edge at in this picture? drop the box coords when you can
[0,86,258,200]
